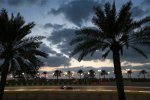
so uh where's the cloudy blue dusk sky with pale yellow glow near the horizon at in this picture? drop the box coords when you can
[0,0,150,77]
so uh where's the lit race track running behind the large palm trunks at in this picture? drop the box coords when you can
[5,86,150,93]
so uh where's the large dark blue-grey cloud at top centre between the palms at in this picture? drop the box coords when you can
[48,0,100,26]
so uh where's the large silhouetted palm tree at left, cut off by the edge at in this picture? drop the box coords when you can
[0,10,47,100]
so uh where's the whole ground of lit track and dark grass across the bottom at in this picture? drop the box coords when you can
[4,86,150,100]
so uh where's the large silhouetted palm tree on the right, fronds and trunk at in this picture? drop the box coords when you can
[70,1,150,100]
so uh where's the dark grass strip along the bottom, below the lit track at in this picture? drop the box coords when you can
[4,90,150,100]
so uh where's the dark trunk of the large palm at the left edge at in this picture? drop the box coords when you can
[0,60,9,100]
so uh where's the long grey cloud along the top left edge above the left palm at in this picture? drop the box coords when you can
[1,0,48,6]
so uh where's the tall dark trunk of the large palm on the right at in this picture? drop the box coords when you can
[113,51,126,100]
